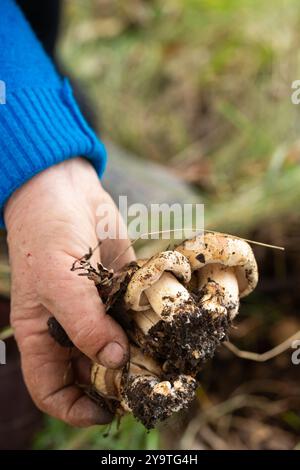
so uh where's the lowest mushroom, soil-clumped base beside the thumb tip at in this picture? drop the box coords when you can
[91,345,196,429]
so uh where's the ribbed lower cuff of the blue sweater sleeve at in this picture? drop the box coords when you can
[0,80,107,227]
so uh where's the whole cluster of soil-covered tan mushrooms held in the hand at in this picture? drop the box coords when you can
[49,232,258,429]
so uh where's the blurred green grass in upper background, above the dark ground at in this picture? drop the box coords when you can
[59,0,300,233]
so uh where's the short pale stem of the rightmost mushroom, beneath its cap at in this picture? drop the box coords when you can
[197,263,239,320]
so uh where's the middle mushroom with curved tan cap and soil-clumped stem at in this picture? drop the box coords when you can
[124,251,205,374]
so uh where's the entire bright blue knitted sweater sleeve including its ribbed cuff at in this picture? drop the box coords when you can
[0,0,106,226]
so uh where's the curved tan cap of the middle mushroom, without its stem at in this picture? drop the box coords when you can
[125,251,191,311]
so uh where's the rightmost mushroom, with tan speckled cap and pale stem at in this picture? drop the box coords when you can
[176,232,258,320]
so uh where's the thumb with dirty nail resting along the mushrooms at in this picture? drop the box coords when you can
[37,252,128,368]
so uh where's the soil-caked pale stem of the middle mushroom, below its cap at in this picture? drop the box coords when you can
[130,272,201,374]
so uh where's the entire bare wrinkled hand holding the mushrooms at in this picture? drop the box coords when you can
[4,158,134,426]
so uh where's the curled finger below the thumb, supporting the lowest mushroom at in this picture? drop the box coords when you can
[19,311,112,426]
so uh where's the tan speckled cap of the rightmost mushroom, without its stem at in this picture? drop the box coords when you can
[176,232,258,297]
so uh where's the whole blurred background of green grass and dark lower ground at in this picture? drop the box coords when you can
[0,0,300,449]
